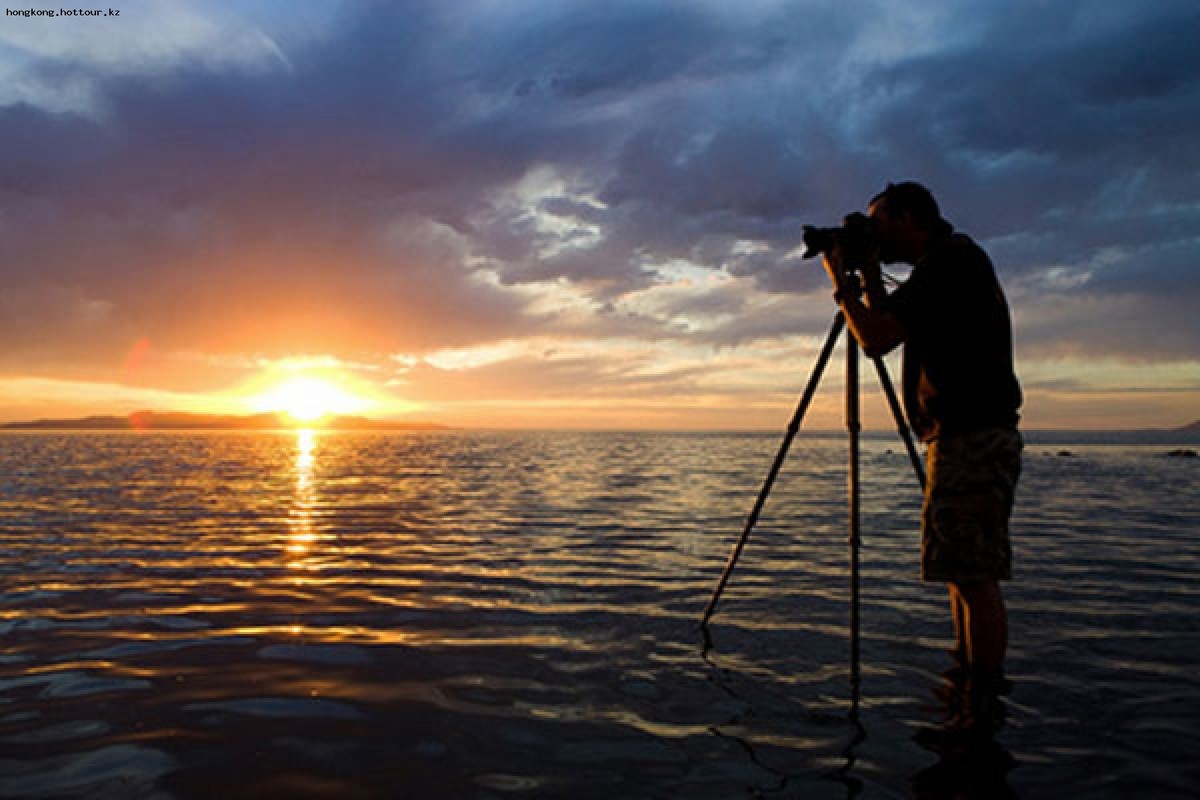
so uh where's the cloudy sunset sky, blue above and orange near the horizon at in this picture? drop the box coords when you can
[0,0,1200,431]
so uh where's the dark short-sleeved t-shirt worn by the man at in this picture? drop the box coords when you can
[887,234,1021,441]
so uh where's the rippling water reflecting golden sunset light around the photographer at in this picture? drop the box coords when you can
[0,432,1200,798]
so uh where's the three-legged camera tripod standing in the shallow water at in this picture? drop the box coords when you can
[700,311,925,690]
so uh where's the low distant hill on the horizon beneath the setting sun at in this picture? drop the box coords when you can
[0,411,449,431]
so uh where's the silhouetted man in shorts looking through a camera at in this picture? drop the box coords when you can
[824,182,1022,714]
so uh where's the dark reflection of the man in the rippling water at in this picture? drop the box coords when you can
[912,669,1018,800]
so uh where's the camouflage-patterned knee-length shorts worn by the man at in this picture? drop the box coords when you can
[920,428,1024,583]
